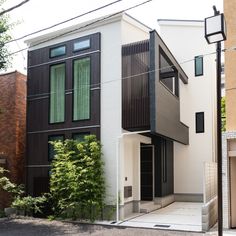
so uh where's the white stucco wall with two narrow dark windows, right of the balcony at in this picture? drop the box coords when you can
[159,21,216,194]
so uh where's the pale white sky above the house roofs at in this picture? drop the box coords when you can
[3,0,223,73]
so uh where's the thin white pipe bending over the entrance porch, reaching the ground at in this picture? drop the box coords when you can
[116,130,151,224]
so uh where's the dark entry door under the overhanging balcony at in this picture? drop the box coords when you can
[140,146,153,201]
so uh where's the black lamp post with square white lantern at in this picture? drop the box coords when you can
[205,6,226,236]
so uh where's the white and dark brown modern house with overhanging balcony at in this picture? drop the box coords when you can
[26,13,215,225]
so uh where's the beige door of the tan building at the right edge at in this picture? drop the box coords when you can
[229,157,236,228]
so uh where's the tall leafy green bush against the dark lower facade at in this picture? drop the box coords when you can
[50,135,105,221]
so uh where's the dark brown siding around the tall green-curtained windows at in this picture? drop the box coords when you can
[26,33,101,195]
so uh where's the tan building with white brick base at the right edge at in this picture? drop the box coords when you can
[222,0,236,228]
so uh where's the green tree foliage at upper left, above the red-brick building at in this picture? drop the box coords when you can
[0,0,13,70]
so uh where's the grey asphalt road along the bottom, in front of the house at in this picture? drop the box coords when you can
[0,218,216,236]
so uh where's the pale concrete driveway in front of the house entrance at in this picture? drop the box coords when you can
[120,202,202,232]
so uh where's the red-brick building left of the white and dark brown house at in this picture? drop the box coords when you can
[0,71,26,209]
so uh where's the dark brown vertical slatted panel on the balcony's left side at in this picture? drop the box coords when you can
[122,41,150,131]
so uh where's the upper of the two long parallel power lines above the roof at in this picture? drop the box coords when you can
[5,0,123,44]
